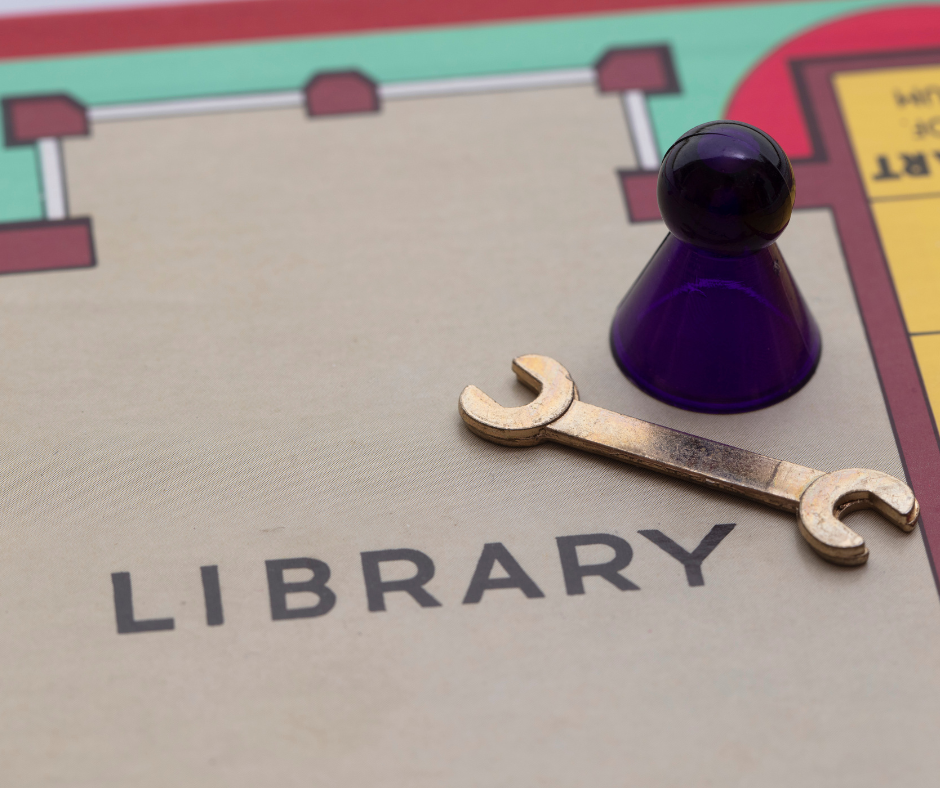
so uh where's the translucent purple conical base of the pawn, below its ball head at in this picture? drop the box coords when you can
[610,234,821,413]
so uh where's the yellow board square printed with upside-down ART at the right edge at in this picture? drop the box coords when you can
[834,66,940,200]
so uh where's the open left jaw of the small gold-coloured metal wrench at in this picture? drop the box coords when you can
[459,355,578,446]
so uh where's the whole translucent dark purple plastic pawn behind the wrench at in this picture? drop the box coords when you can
[610,121,821,413]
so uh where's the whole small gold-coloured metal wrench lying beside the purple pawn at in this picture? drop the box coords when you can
[460,355,920,566]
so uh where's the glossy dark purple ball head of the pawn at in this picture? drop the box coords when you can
[656,121,795,255]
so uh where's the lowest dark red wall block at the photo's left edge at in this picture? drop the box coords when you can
[0,219,95,274]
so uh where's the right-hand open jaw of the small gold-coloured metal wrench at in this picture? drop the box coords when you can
[800,468,920,566]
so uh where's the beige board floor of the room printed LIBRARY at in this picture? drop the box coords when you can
[0,88,940,788]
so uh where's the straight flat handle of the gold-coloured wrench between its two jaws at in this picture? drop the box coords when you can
[543,399,825,512]
